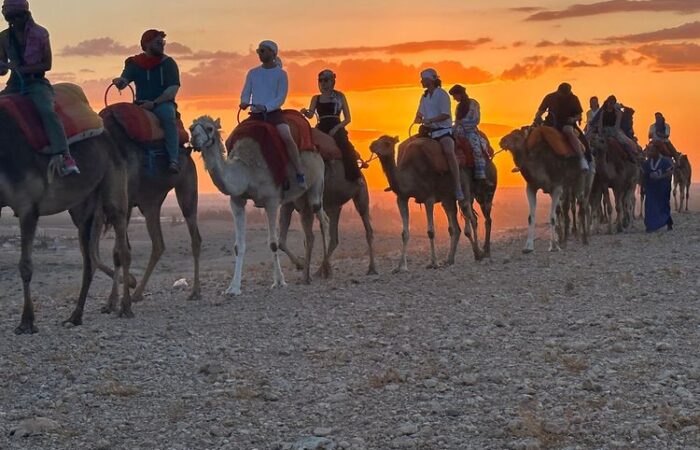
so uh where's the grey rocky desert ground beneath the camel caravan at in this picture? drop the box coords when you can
[0,193,700,450]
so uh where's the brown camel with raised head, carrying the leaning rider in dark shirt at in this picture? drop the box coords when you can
[500,127,593,253]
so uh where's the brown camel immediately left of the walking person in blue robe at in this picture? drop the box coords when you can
[590,135,641,233]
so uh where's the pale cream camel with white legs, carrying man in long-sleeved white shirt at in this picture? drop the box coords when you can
[190,116,328,296]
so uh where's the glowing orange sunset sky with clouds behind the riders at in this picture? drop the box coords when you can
[16,0,700,192]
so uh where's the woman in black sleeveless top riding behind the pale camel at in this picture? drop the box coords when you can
[301,69,362,181]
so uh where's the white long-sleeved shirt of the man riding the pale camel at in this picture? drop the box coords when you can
[241,66,289,112]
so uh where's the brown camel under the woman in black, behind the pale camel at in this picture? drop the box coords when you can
[279,130,377,277]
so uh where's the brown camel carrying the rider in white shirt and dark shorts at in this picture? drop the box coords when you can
[370,136,481,272]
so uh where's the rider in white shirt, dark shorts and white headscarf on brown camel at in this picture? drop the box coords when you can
[414,69,464,201]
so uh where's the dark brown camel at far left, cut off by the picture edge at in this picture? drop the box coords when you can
[0,110,133,334]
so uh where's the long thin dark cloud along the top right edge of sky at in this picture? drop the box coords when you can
[526,0,700,21]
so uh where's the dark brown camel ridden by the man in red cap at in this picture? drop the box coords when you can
[96,110,202,302]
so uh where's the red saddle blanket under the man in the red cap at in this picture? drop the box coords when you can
[100,103,190,146]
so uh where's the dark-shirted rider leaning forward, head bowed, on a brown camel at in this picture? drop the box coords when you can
[534,83,589,171]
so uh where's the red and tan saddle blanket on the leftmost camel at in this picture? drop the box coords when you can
[0,83,104,154]
